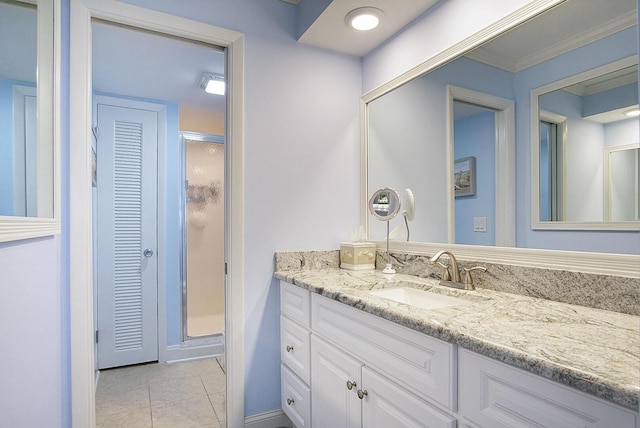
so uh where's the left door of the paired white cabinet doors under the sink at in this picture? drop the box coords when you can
[311,335,362,428]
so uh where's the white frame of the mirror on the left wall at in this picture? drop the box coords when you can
[0,0,60,242]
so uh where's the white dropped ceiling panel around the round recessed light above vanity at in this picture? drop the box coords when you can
[298,0,438,56]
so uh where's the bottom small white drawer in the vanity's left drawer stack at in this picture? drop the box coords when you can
[280,364,311,428]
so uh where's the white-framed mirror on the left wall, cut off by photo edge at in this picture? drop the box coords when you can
[0,0,60,242]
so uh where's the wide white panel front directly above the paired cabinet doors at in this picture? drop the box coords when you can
[311,294,457,410]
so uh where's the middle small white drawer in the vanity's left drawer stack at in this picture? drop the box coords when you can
[280,316,310,384]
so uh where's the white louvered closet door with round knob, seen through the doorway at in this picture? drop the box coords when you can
[96,104,158,369]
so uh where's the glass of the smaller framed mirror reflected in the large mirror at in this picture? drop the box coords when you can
[534,63,639,222]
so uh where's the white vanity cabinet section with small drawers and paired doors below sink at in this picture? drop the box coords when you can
[280,281,457,428]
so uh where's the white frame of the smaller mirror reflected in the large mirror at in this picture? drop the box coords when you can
[530,55,640,230]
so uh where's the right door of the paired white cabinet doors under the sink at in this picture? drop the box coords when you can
[362,367,456,428]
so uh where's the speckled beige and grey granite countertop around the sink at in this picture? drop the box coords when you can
[274,268,640,411]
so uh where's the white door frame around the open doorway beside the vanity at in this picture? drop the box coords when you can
[69,0,244,427]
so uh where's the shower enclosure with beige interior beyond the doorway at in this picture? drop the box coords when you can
[182,132,225,344]
